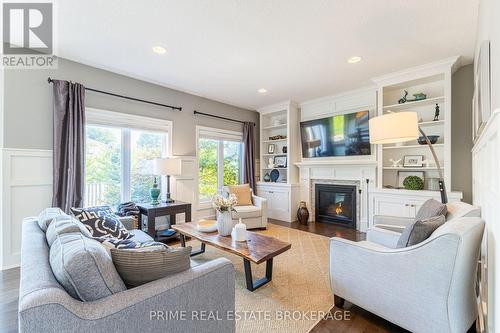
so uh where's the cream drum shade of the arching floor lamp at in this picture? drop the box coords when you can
[369,112,419,144]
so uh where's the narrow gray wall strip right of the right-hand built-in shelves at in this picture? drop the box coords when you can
[451,65,474,203]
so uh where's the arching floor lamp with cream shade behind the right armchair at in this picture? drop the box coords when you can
[370,112,448,203]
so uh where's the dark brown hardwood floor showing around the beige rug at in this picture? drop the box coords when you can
[0,220,475,333]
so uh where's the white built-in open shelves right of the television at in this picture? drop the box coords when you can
[374,57,458,191]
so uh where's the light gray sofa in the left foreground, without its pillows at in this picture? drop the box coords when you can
[19,214,235,333]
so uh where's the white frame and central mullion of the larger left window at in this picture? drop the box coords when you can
[85,107,173,202]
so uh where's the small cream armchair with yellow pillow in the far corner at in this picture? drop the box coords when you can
[222,186,267,229]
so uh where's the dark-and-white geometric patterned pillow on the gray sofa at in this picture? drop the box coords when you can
[71,206,131,239]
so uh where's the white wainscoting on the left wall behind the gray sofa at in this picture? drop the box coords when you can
[1,148,52,269]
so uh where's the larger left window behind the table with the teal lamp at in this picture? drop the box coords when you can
[84,109,170,206]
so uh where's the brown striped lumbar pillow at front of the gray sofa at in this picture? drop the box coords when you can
[111,246,191,287]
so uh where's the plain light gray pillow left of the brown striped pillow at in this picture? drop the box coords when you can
[49,232,127,301]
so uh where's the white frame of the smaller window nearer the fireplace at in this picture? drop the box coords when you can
[195,126,244,210]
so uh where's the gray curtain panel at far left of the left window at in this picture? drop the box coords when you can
[52,80,85,213]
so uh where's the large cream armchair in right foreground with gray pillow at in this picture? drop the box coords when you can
[330,200,484,333]
